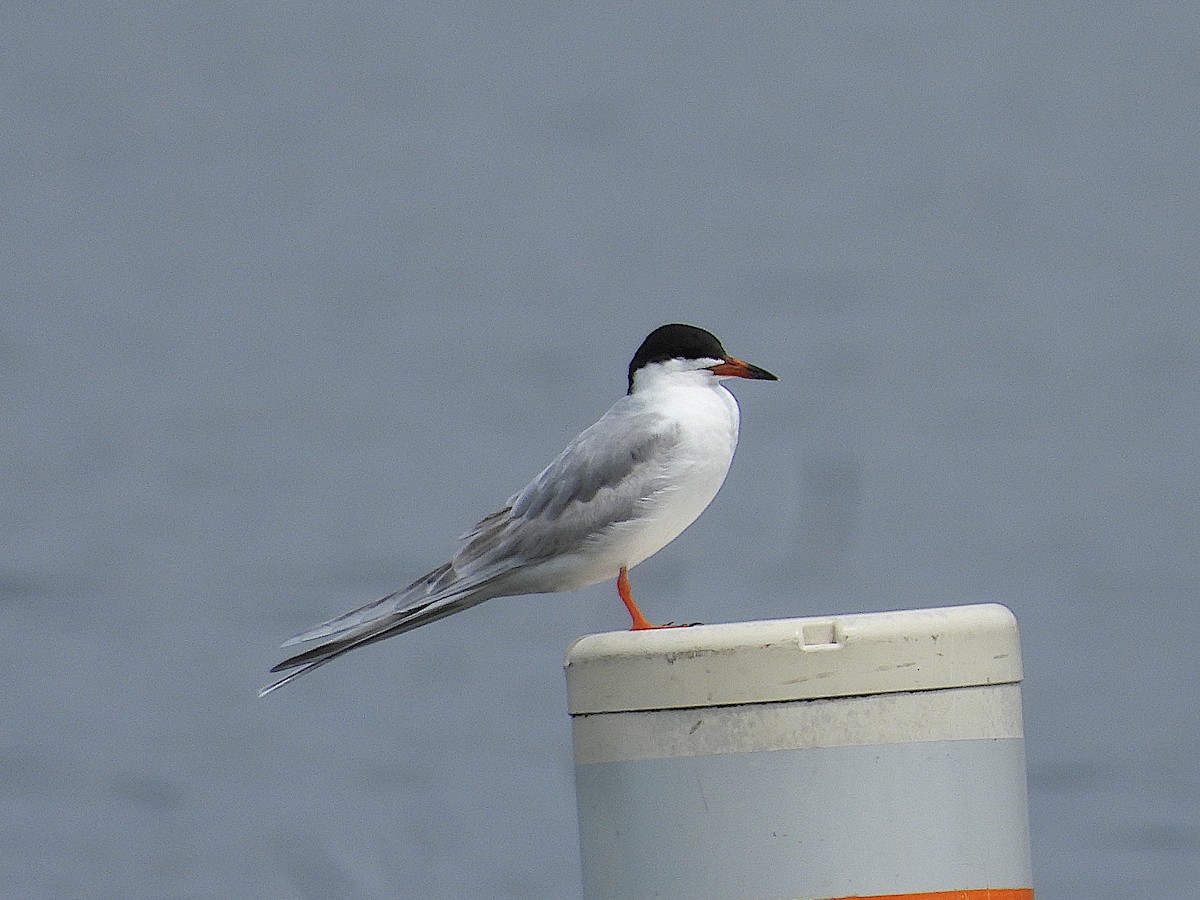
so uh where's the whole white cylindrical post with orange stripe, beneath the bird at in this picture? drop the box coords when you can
[566,604,1033,900]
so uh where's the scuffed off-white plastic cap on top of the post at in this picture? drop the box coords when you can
[565,604,1021,715]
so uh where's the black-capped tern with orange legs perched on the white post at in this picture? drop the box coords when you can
[259,323,779,697]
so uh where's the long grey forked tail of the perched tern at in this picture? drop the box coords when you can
[258,564,494,697]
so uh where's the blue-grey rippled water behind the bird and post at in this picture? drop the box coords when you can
[0,2,1200,900]
